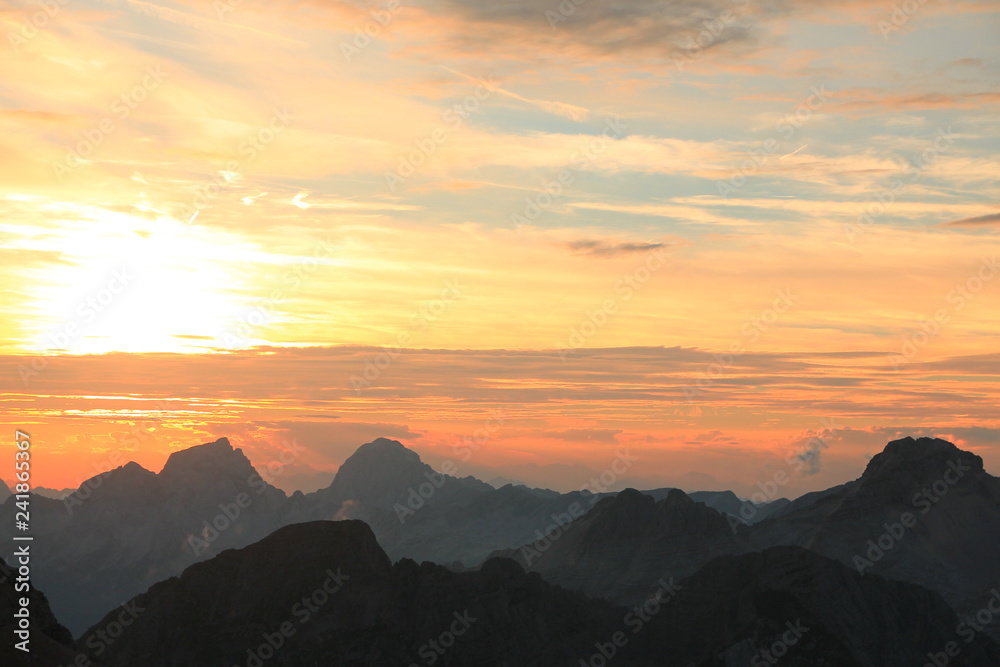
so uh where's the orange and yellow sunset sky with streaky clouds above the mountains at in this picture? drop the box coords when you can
[0,0,1000,496]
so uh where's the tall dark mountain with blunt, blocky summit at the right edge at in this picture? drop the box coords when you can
[746,438,1000,636]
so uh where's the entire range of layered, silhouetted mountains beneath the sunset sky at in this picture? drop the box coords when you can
[0,438,1000,665]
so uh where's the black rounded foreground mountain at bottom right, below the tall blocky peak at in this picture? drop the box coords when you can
[649,547,1000,667]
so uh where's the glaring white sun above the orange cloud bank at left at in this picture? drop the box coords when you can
[24,207,258,354]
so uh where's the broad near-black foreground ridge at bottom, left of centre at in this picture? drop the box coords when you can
[78,520,654,667]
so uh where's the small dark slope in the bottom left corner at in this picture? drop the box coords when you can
[0,559,77,667]
